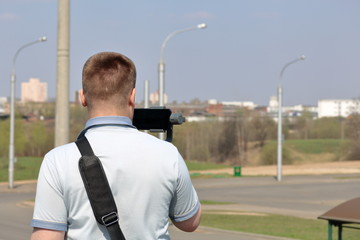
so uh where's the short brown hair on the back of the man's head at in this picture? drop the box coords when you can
[82,52,136,106]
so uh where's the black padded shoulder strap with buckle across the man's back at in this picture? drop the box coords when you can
[75,136,125,240]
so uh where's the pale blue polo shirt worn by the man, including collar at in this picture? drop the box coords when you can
[32,116,200,240]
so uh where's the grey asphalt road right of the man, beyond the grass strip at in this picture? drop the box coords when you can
[193,174,360,219]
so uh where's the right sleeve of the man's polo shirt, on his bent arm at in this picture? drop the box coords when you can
[169,154,200,222]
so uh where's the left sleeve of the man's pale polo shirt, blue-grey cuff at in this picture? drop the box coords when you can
[31,154,67,231]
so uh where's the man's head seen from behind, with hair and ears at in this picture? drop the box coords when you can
[81,52,136,115]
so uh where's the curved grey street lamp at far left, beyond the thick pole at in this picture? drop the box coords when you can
[9,36,47,188]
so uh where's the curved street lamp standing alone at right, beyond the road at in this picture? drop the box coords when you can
[277,55,305,182]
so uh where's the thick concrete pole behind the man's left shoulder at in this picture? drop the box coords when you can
[55,0,70,146]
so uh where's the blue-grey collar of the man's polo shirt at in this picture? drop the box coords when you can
[78,116,135,139]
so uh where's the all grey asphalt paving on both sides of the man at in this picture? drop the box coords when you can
[0,175,360,240]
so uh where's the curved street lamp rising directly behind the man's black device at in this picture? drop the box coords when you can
[159,23,207,107]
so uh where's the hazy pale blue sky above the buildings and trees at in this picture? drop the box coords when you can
[0,0,360,106]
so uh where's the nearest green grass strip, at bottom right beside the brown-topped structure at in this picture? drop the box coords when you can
[201,212,360,240]
